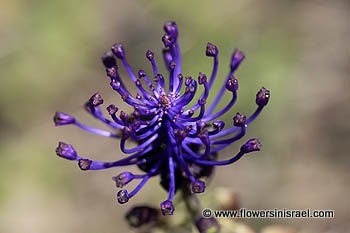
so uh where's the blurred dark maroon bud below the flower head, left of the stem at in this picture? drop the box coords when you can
[125,206,159,227]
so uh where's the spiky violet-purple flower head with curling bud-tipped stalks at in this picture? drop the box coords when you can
[54,22,270,215]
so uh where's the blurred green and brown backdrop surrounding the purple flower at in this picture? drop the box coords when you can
[0,0,350,233]
